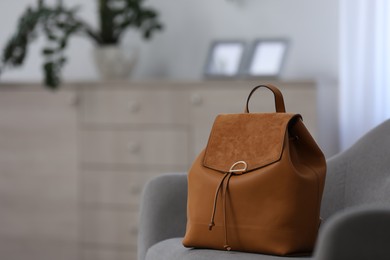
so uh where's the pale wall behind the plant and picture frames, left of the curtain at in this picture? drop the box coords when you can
[0,0,339,81]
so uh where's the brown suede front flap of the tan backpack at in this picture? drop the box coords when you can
[203,113,300,173]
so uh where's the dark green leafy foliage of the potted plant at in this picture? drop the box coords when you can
[0,0,163,89]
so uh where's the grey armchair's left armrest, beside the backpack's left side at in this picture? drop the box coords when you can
[138,174,187,260]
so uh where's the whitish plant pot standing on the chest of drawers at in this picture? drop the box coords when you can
[93,45,138,80]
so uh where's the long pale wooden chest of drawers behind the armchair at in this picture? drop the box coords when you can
[0,81,318,260]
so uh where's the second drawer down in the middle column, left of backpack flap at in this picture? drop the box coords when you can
[81,129,188,166]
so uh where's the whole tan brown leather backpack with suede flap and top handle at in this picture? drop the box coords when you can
[183,85,326,255]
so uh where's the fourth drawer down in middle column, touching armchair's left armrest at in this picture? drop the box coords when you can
[81,207,138,249]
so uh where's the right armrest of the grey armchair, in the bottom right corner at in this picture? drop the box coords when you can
[314,206,390,260]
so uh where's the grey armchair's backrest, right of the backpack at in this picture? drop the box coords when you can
[321,120,390,219]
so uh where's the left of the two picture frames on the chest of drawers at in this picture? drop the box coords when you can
[204,40,245,78]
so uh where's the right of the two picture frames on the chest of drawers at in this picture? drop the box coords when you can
[244,39,289,78]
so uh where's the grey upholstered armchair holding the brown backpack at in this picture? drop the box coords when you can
[138,120,390,260]
